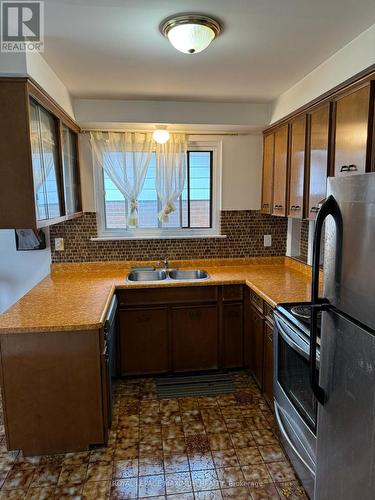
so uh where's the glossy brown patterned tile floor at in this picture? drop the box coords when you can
[0,372,307,500]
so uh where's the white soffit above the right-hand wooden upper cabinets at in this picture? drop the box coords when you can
[270,25,375,123]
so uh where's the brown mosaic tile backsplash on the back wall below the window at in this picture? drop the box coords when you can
[50,210,287,262]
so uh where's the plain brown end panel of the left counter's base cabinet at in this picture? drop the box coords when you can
[0,330,107,455]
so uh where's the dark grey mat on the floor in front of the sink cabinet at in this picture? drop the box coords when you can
[156,373,234,399]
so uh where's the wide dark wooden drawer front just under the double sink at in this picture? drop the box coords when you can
[118,286,217,307]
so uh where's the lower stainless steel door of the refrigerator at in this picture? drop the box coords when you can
[315,312,375,500]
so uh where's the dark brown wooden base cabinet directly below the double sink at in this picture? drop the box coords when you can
[118,285,245,375]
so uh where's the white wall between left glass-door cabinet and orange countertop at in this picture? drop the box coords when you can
[0,229,51,313]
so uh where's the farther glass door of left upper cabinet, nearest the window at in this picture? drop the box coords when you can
[61,125,81,215]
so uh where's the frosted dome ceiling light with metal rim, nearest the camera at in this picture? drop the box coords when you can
[160,14,222,54]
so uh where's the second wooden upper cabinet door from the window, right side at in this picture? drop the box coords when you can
[272,125,288,216]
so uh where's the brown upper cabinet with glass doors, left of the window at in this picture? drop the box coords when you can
[0,78,81,229]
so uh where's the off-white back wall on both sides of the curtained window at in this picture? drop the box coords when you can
[79,134,262,212]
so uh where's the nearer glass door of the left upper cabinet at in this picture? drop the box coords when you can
[39,106,62,219]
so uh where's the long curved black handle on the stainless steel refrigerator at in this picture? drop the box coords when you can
[309,195,342,405]
